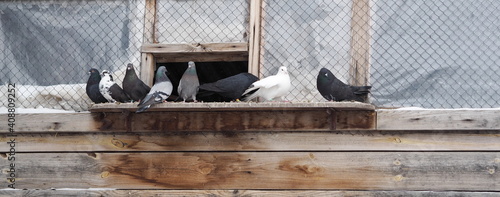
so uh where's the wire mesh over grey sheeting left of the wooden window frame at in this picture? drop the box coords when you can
[0,0,144,111]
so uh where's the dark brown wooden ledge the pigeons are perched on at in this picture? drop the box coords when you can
[87,102,376,132]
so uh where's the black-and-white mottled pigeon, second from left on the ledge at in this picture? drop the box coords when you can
[99,70,130,103]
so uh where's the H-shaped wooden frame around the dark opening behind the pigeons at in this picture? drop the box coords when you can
[141,0,260,85]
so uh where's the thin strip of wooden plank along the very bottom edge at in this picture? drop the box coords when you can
[0,189,500,197]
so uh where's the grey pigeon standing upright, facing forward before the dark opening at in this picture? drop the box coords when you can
[177,61,200,102]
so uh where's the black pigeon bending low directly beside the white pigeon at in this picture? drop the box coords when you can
[200,73,259,100]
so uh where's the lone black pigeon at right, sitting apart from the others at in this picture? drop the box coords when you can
[317,68,371,102]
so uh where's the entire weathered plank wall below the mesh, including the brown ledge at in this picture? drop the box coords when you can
[0,104,500,196]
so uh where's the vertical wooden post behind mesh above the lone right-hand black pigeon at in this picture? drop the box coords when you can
[349,0,371,86]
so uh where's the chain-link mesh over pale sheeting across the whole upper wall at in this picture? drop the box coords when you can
[0,0,500,111]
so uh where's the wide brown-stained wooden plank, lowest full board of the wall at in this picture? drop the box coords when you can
[0,152,500,191]
